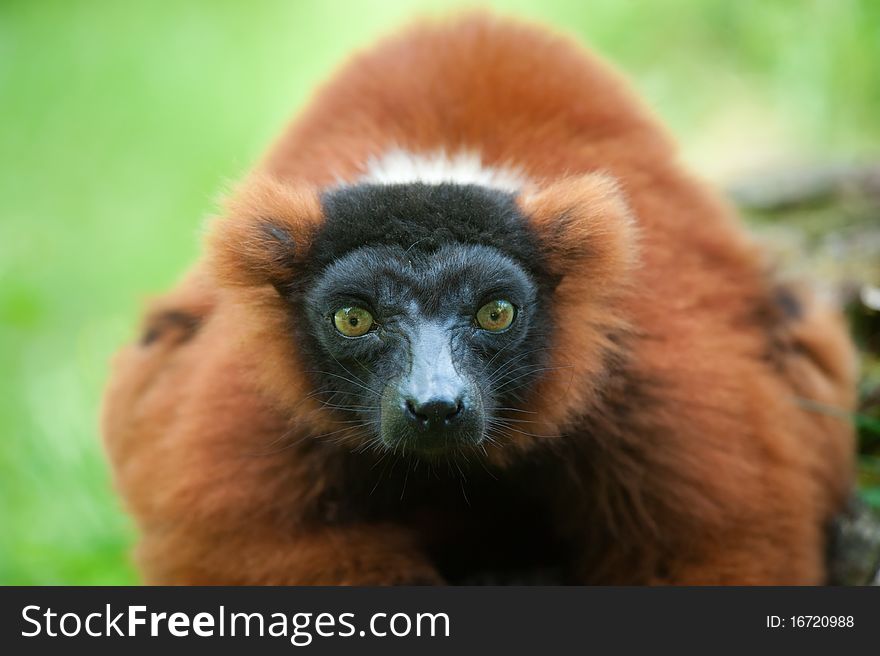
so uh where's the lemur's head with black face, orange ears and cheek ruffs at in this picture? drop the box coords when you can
[213,176,633,458]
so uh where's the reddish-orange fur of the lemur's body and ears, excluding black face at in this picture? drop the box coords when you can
[104,17,854,584]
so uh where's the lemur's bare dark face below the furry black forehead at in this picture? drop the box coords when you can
[305,243,545,455]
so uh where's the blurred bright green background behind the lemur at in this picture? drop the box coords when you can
[0,0,880,584]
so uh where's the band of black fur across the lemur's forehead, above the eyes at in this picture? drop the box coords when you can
[309,183,549,282]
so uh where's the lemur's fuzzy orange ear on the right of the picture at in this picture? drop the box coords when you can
[519,173,638,289]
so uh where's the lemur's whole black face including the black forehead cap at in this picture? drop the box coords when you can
[288,185,549,457]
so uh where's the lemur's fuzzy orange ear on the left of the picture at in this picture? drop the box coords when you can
[208,175,323,294]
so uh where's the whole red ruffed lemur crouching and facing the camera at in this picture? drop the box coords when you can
[103,15,855,585]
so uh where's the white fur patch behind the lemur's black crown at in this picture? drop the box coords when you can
[358,148,528,193]
